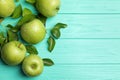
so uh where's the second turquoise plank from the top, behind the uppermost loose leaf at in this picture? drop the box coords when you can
[46,14,120,38]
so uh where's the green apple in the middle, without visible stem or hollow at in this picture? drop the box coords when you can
[20,19,46,44]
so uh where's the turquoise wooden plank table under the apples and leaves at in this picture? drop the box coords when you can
[0,0,120,80]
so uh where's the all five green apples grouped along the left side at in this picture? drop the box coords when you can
[0,0,60,76]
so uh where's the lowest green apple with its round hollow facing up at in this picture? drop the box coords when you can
[22,54,44,77]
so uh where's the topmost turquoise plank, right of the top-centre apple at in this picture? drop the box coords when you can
[59,0,120,14]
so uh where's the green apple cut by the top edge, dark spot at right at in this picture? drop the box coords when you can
[36,0,60,17]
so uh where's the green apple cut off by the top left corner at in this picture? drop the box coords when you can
[0,0,15,17]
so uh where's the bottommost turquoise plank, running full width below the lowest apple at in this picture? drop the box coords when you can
[0,64,120,80]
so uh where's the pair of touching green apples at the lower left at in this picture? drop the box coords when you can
[1,41,44,76]
